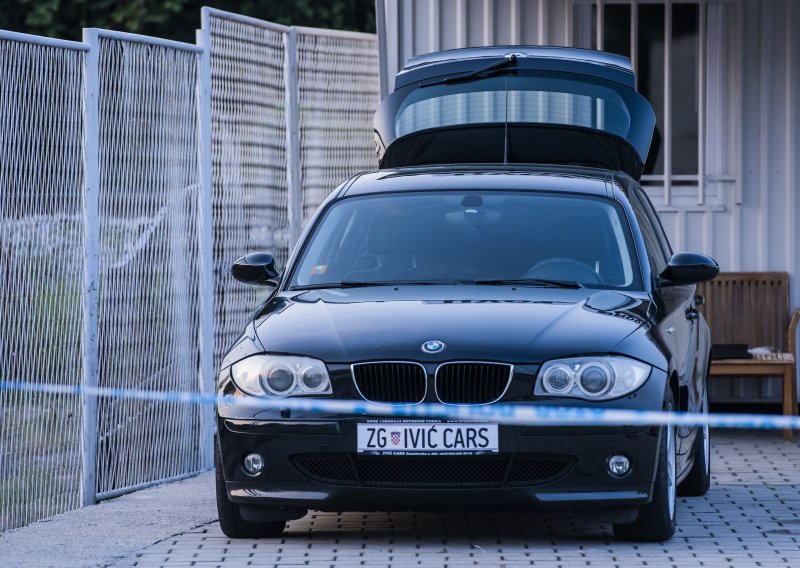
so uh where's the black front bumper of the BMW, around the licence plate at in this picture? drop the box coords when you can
[218,416,660,512]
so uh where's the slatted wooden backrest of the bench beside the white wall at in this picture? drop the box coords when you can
[699,272,789,351]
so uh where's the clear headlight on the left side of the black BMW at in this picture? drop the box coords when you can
[231,355,333,397]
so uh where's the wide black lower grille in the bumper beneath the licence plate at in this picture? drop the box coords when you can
[292,454,575,487]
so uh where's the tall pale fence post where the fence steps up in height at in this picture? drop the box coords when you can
[197,15,216,469]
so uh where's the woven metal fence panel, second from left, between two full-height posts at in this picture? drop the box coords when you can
[90,32,202,499]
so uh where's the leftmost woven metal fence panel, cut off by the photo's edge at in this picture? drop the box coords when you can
[0,33,85,530]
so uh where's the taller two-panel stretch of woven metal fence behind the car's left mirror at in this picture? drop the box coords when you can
[200,8,380,368]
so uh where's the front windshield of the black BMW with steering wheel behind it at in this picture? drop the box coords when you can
[290,191,640,289]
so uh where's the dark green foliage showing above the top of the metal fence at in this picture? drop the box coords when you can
[0,0,375,43]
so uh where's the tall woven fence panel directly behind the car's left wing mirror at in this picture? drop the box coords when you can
[202,13,291,368]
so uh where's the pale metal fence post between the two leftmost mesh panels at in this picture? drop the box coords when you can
[81,29,100,506]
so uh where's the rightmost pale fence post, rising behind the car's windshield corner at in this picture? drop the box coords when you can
[283,26,303,245]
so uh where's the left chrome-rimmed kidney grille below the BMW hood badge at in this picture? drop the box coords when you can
[353,362,427,403]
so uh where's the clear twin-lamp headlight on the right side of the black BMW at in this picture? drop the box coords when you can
[533,357,650,400]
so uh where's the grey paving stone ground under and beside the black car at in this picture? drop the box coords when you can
[114,432,800,568]
